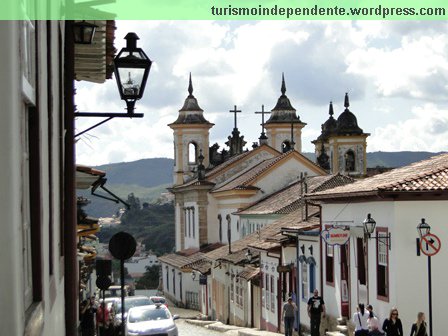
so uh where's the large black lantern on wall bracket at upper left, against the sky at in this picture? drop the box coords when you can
[114,33,152,114]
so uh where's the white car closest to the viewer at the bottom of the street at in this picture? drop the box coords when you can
[126,304,179,336]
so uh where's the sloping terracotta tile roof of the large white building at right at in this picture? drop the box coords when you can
[307,153,448,199]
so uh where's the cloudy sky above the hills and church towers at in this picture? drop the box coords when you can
[76,21,448,165]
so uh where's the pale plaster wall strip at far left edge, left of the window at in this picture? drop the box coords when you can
[0,21,25,335]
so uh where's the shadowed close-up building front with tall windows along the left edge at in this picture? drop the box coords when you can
[0,19,117,335]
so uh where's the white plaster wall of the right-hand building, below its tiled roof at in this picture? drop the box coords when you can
[323,201,448,335]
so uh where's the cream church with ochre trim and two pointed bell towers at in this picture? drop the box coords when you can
[160,76,365,325]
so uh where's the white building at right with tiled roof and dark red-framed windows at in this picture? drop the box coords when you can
[309,154,448,335]
